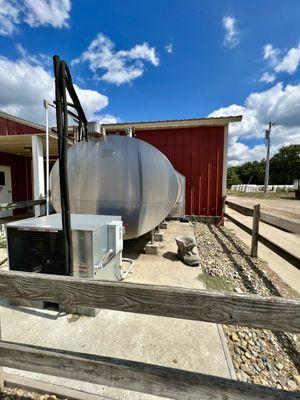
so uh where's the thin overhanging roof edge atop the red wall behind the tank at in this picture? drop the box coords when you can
[101,115,243,132]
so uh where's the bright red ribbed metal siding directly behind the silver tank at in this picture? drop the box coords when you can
[135,126,224,216]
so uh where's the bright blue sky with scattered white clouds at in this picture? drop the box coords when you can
[0,0,300,165]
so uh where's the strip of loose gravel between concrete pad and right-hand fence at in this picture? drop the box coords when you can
[194,223,300,391]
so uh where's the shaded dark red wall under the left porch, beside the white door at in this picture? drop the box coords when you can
[0,152,32,214]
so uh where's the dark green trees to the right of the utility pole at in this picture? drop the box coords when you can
[270,144,300,185]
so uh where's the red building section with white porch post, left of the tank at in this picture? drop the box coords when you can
[0,112,67,217]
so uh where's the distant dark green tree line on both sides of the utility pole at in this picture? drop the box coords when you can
[227,144,300,187]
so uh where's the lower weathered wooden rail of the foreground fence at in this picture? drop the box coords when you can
[0,342,300,400]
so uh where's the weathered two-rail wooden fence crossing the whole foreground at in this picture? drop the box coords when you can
[0,271,300,400]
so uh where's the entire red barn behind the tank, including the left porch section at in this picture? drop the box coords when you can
[0,112,242,217]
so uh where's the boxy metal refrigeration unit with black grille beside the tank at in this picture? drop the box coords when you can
[7,213,127,280]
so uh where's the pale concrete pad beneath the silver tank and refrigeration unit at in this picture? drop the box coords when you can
[0,221,235,400]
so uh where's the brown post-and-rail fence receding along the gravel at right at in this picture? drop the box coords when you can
[224,201,300,269]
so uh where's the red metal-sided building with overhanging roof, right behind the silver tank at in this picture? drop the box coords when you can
[102,116,242,217]
